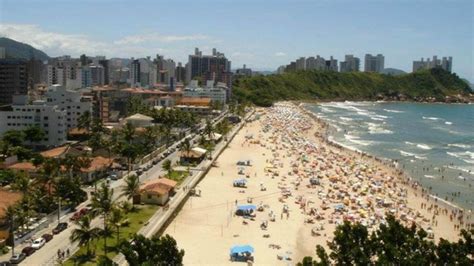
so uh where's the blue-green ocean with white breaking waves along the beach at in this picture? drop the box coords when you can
[305,102,474,210]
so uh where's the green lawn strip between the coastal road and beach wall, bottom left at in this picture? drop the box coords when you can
[64,205,159,265]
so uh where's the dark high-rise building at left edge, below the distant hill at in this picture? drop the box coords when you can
[0,59,28,105]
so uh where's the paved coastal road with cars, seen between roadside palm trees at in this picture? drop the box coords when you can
[16,113,230,266]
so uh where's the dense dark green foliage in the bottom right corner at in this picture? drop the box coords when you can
[298,216,474,266]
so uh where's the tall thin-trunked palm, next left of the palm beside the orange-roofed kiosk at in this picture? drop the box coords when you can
[92,183,114,255]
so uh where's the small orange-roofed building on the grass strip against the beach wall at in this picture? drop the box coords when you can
[140,178,177,206]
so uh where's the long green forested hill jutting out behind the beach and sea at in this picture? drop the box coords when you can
[233,68,471,106]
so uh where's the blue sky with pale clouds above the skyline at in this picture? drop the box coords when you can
[0,0,474,82]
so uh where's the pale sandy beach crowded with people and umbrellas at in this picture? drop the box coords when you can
[164,102,471,265]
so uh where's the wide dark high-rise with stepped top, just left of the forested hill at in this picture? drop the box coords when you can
[186,48,232,88]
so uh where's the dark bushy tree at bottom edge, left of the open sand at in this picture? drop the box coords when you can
[119,235,184,266]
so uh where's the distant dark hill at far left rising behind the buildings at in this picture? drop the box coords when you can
[0,37,49,61]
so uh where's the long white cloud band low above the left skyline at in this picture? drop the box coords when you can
[0,24,213,57]
